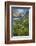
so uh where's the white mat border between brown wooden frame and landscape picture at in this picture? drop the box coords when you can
[9,5,32,40]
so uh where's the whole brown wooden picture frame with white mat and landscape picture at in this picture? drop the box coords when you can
[5,1,35,44]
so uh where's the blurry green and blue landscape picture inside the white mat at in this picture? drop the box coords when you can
[11,7,29,36]
